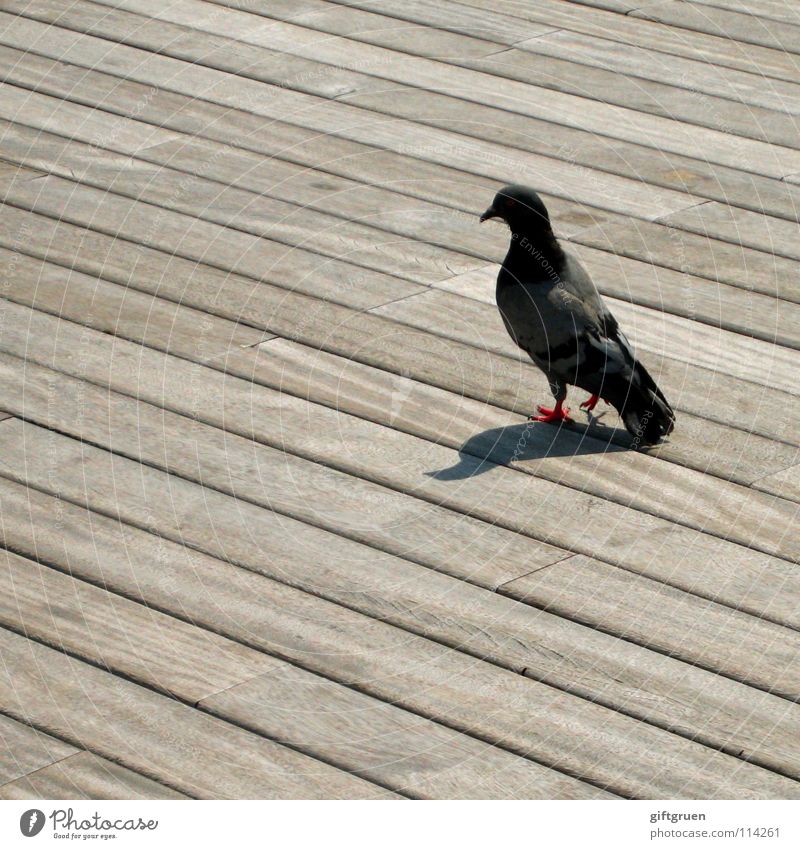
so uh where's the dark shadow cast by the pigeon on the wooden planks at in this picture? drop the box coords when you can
[425,417,632,481]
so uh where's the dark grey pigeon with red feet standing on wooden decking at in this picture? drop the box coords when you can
[480,186,675,447]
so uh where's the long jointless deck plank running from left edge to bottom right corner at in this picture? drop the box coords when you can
[0,480,776,798]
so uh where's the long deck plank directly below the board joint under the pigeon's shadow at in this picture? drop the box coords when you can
[0,380,800,784]
